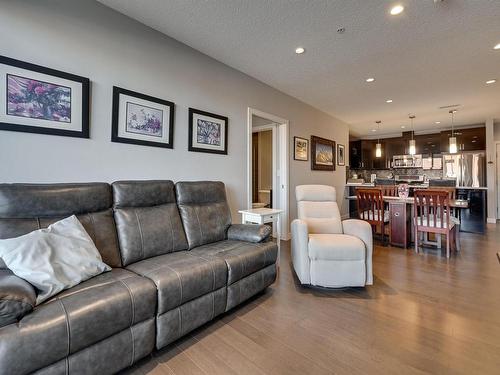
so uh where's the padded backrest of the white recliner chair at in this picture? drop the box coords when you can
[295,185,343,234]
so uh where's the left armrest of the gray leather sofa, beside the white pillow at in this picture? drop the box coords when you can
[0,269,36,327]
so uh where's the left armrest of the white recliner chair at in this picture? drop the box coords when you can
[292,219,311,284]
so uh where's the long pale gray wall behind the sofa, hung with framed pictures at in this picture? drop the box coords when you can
[0,0,348,220]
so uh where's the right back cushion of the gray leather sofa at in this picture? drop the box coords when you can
[175,181,231,249]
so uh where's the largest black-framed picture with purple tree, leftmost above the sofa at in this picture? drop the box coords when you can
[0,56,90,138]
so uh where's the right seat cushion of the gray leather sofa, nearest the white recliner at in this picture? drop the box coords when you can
[191,240,278,285]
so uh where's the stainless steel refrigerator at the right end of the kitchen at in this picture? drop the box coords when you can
[443,151,486,187]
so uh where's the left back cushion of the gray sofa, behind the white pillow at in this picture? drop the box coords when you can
[0,183,121,267]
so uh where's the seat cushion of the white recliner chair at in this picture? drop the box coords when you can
[309,234,366,260]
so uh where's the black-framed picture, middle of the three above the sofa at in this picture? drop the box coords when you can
[111,86,175,148]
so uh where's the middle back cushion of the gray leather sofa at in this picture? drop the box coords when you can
[112,180,187,266]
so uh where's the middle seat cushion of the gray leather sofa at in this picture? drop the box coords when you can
[127,251,227,315]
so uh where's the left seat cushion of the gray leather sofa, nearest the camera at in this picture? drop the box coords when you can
[0,269,156,373]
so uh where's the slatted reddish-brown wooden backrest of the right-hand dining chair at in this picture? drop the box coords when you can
[414,188,450,233]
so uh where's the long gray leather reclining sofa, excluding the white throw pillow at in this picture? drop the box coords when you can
[0,181,277,374]
